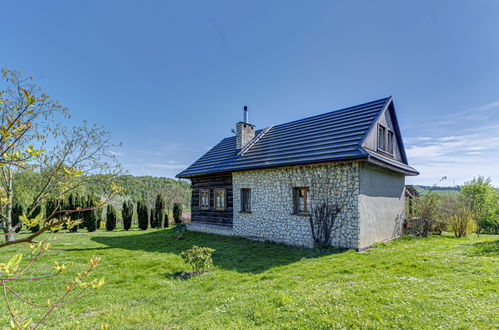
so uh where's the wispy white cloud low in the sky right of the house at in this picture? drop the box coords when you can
[405,101,499,185]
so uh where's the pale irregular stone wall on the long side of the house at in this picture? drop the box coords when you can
[232,162,359,248]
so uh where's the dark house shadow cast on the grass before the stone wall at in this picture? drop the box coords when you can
[83,229,345,273]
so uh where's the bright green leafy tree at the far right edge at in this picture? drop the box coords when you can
[460,176,499,235]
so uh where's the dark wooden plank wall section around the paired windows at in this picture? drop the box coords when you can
[191,173,233,225]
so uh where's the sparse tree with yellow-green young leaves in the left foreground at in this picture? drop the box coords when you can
[0,69,122,329]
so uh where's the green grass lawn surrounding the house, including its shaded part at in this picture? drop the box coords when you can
[0,230,499,329]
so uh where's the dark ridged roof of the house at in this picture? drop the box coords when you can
[177,97,417,178]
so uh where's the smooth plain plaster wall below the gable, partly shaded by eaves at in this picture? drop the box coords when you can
[358,164,405,249]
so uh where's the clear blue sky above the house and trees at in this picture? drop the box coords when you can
[0,0,499,185]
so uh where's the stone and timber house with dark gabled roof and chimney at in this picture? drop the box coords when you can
[177,97,419,250]
